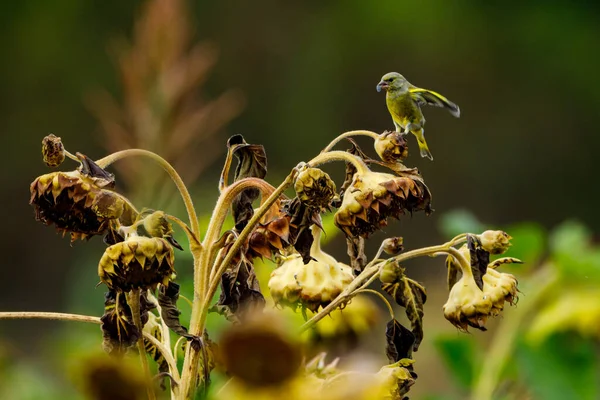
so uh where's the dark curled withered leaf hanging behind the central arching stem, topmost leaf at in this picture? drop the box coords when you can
[227,135,267,231]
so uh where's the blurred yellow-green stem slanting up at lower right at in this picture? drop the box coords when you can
[471,269,558,400]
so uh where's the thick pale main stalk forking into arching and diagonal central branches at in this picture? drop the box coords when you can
[179,169,298,400]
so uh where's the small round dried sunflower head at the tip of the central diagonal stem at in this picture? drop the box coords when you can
[294,168,336,210]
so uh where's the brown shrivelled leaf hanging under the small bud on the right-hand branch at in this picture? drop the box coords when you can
[381,266,427,351]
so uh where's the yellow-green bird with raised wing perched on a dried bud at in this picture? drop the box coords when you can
[377,72,460,160]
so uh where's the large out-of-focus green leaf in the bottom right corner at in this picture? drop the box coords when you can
[517,334,600,400]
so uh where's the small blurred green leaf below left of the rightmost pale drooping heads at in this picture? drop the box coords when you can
[434,335,478,389]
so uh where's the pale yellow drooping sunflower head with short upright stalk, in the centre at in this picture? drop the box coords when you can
[269,229,353,312]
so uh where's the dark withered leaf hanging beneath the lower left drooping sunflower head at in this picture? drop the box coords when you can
[100,290,156,354]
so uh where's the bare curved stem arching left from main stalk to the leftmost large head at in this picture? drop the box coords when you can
[96,149,200,238]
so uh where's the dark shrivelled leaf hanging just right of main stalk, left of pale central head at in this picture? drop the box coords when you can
[214,258,265,322]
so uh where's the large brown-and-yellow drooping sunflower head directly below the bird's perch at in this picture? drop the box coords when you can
[335,171,432,237]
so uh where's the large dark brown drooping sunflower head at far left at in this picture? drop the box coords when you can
[29,155,129,241]
